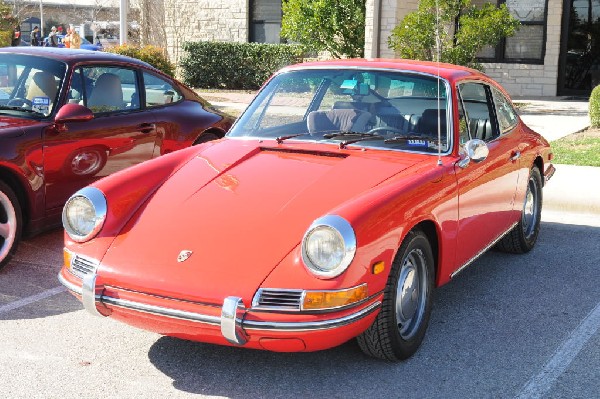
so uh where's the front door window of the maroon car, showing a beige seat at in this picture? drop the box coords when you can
[80,66,140,114]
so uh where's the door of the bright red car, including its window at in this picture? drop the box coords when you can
[455,82,520,267]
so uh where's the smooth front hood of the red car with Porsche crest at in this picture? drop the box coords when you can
[100,139,423,304]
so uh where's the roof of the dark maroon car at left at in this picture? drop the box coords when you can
[0,46,156,70]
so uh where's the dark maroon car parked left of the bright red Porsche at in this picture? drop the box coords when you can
[0,47,233,267]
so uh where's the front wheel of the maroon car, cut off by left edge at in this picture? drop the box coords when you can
[0,181,23,269]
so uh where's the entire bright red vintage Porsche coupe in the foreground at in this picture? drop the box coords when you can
[59,60,554,360]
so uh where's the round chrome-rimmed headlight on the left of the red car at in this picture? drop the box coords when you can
[62,187,106,242]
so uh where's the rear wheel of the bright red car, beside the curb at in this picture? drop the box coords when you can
[496,166,542,254]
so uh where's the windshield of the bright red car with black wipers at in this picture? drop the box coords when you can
[229,69,451,153]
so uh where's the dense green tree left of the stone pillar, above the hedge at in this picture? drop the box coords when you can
[281,0,365,58]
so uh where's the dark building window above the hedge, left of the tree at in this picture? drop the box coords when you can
[250,0,282,43]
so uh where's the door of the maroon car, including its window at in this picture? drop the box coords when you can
[43,65,156,210]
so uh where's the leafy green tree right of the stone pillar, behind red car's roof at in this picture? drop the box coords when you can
[388,0,520,69]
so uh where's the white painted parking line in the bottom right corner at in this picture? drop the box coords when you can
[517,303,600,399]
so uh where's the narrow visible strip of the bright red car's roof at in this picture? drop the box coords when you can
[283,58,489,81]
